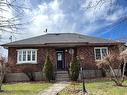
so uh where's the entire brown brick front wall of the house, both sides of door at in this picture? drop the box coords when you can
[8,46,119,73]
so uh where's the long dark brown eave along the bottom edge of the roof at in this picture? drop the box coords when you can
[1,42,125,49]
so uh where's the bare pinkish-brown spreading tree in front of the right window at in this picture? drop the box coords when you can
[97,50,127,86]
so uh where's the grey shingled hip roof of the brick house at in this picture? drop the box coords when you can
[2,33,124,47]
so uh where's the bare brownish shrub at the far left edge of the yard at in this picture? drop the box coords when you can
[0,56,6,92]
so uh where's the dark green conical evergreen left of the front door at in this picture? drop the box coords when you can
[43,53,54,82]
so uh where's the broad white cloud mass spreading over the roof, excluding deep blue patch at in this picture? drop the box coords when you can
[1,0,127,40]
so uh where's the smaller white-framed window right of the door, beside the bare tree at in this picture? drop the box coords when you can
[94,47,108,60]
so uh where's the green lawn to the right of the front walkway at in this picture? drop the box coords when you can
[59,81,127,95]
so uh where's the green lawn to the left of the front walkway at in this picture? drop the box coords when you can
[0,82,52,95]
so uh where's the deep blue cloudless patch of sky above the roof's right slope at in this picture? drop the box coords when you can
[91,20,127,40]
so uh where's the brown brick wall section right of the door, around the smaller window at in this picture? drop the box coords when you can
[77,46,119,69]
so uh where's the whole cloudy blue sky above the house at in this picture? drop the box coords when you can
[0,0,127,55]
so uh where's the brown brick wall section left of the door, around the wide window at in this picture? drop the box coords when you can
[8,48,56,73]
